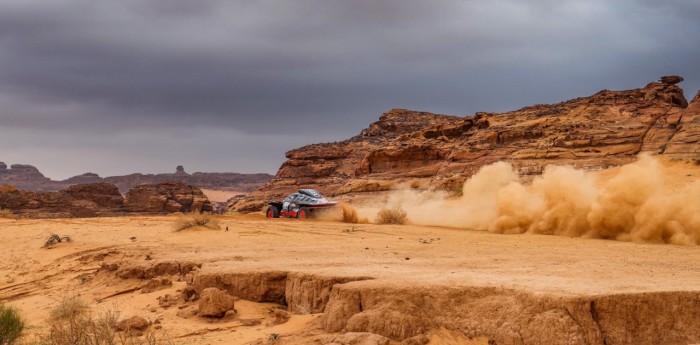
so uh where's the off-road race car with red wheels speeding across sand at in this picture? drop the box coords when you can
[265,189,337,219]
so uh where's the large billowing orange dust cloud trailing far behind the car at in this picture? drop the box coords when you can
[388,155,700,245]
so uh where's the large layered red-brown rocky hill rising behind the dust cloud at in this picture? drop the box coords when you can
[229,76,700,212]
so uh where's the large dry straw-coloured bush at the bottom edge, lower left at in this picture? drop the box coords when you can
[33,298,171,345]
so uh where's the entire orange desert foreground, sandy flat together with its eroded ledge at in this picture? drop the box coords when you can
[0,157,700,344]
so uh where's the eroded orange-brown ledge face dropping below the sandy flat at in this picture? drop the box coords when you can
[185,271,700,345]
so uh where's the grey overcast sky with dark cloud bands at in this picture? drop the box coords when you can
[0,0,700,179]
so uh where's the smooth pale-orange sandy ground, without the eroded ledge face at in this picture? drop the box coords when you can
[0,157,700,345]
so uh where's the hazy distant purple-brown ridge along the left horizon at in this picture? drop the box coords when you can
[0,162,273,194]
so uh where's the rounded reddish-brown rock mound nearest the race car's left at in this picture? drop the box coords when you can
[124,182,213,213]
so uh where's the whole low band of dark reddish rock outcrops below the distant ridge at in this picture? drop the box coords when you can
[0,182,212,218]
